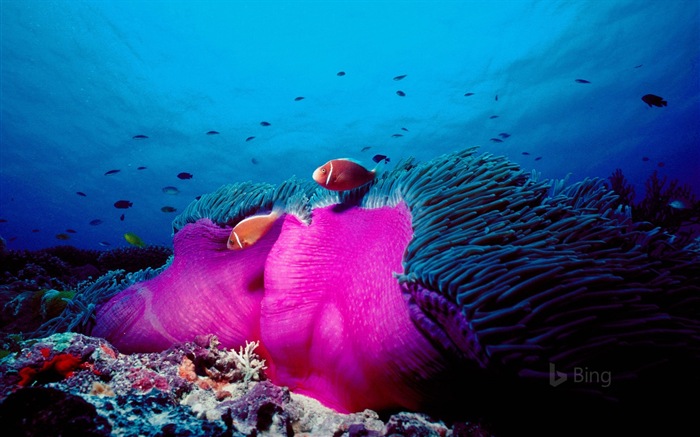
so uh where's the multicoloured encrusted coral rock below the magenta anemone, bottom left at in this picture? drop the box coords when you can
[0,334,489,437]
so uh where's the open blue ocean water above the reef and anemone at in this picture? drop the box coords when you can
[0,0,700,249]
